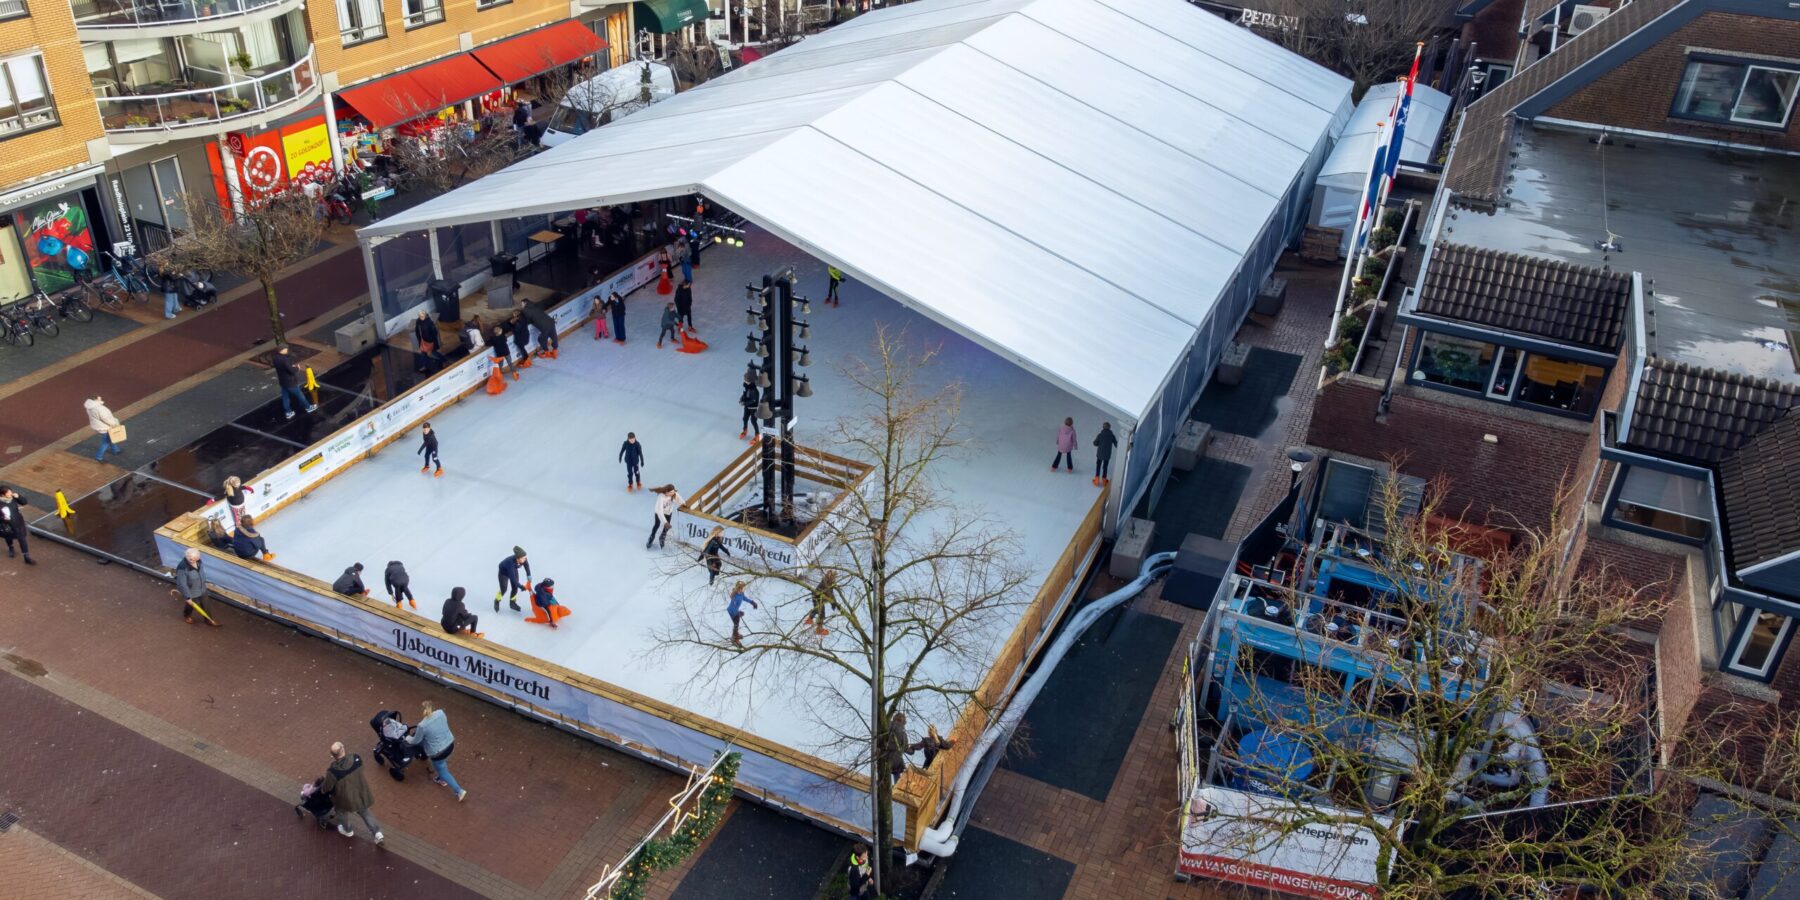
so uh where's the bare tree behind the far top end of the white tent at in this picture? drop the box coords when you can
[1244,0,1456,97]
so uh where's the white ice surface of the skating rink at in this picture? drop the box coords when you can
[263,230,1120,756]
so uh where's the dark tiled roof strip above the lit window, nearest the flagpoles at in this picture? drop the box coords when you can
[1418,243,1631,351]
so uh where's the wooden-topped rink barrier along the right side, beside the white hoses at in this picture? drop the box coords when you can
[895,490,1111,848]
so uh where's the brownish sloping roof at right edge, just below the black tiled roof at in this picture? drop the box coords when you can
[1719,414,1800,569]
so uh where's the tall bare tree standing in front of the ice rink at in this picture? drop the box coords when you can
[653,329,1028,889]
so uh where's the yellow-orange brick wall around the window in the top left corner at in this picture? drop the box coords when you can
[0,2,104,189]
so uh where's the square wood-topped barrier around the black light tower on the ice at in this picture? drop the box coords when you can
[675,443,875,565]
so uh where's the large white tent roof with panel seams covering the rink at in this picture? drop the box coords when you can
[362,0,1350,421]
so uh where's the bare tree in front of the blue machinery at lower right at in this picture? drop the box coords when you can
[1211,481,1708,898]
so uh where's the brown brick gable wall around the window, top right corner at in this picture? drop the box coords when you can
[1544,13,1800,149]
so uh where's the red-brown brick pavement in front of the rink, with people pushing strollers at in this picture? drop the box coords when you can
[0,542,738,898]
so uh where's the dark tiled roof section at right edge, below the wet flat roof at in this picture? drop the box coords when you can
[1625,356,1800,463]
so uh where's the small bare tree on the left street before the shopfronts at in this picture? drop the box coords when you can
[158,182,328,344]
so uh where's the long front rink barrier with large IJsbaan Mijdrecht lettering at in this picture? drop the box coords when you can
[157,515,878,835]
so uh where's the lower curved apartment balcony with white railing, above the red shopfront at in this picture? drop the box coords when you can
[97,49,319,144]
